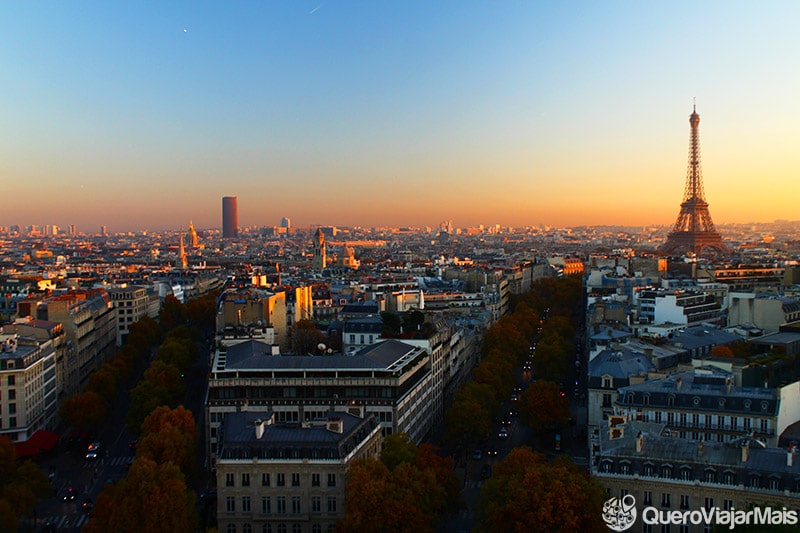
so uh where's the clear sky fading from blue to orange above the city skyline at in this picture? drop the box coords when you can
[0,0,800,231]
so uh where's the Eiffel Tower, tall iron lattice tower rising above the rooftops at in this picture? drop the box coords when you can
[661,107,727,255]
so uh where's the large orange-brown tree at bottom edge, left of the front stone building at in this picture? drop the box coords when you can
[83,458,198,533]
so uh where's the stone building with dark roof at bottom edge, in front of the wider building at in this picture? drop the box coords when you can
[216,410,381,533]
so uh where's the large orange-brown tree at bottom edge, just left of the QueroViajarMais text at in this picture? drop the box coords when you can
[473,447,607,533]
